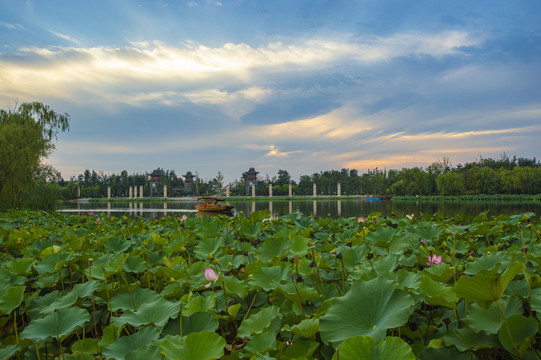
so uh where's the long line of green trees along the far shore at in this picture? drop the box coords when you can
[56,154,541,198]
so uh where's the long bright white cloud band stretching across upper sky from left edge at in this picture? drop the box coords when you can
[0,32,479,102]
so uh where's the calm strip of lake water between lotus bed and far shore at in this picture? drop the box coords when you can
[60,199,541,218]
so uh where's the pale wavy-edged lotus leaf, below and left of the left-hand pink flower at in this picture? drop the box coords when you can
[111,298,180,328]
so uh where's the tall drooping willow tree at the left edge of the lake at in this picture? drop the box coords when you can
[0,102,70,209]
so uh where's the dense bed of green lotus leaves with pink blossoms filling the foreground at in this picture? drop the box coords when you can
[0,210,541,360]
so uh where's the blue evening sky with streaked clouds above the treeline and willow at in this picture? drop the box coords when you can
[0,0,541,183]
